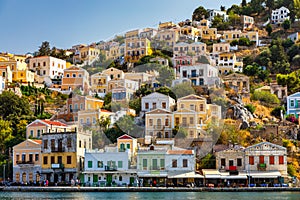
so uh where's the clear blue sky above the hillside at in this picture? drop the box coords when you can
[0,0,242,54]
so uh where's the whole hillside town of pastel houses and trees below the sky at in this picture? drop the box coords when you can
[0,0,300,187]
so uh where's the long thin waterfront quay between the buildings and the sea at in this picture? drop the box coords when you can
[0,186,300,192]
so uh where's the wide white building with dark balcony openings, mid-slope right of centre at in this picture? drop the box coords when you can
[180,64,219,85]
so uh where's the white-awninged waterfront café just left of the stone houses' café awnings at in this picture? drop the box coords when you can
[167,171,204,187]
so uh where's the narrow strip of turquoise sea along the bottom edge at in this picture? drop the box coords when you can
[0,192,300,200]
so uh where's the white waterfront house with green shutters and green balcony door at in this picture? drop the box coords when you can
[83,150,137,186]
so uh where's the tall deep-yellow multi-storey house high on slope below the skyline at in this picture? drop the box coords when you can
[125,37,152,63]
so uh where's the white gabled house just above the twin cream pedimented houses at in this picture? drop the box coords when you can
[142,92,176,112]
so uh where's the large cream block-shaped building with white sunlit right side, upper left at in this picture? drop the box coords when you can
[29,56,66,79]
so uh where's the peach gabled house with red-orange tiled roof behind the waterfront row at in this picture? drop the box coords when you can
[26,119,70,139]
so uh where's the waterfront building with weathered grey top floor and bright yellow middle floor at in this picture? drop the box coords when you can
[42,128,92,183]
